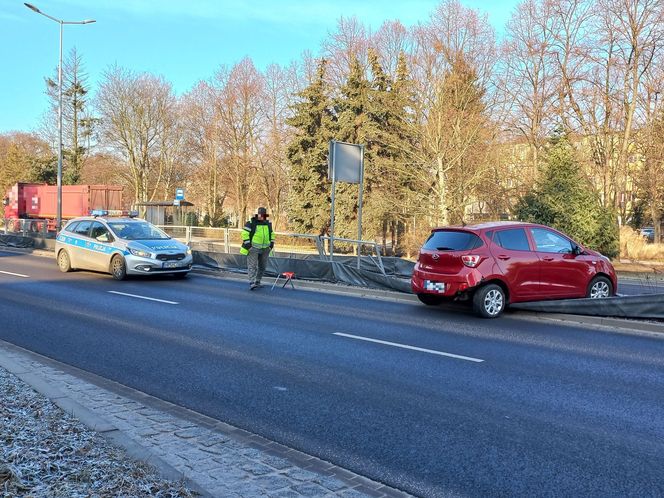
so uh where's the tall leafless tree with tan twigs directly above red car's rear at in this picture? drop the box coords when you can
[413,0,495,224]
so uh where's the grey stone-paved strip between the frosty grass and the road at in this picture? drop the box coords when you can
[0,341,409,498]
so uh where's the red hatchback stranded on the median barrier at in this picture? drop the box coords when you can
[411,222,618,318]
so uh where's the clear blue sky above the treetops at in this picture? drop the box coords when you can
[0,0,517,133]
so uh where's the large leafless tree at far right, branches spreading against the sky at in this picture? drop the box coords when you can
[553,0,664,223]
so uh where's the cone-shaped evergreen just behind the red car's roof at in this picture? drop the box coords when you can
[515,133,619,258]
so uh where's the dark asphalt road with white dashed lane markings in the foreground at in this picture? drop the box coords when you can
[0,252,664,497]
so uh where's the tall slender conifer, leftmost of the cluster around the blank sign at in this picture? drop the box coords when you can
[287,59,334,234]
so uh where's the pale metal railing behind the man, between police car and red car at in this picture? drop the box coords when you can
[158,225,385,275]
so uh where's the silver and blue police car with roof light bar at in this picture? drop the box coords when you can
[55,211,193,280]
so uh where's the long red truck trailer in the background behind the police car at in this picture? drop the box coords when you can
[3,183,123,230]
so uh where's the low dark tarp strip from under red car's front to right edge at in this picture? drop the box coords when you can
[511,294,664,320]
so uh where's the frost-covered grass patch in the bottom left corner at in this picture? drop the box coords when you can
[0,368,196,497]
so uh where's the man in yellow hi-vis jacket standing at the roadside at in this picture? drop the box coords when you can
[240,207,274,290]
